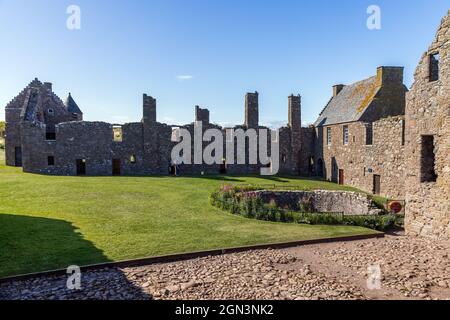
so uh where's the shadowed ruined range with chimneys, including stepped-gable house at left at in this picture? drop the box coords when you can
[6,84,302,175]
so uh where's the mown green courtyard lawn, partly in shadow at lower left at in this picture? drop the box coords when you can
[0,151,373,277]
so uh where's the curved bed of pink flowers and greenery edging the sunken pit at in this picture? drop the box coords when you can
[210,185,397,231]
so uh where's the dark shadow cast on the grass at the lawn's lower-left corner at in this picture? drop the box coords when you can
[0,213,151,299]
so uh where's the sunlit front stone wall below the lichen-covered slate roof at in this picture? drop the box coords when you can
[314,116,406,199]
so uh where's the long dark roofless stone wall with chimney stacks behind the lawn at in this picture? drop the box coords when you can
[11,94,301,175]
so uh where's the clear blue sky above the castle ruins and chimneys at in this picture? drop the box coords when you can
[0,0,450,125]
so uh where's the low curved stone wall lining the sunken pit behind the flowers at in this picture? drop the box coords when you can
[256,190,380,215]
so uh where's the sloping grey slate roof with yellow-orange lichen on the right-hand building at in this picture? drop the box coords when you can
[314,76,380,127]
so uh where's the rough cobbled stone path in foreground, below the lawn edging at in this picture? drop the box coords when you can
[0,232,450,300]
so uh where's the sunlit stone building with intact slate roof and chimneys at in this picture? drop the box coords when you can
[312,67,407,198]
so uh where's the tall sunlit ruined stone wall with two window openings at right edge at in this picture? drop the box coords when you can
[405,11,450,239]
